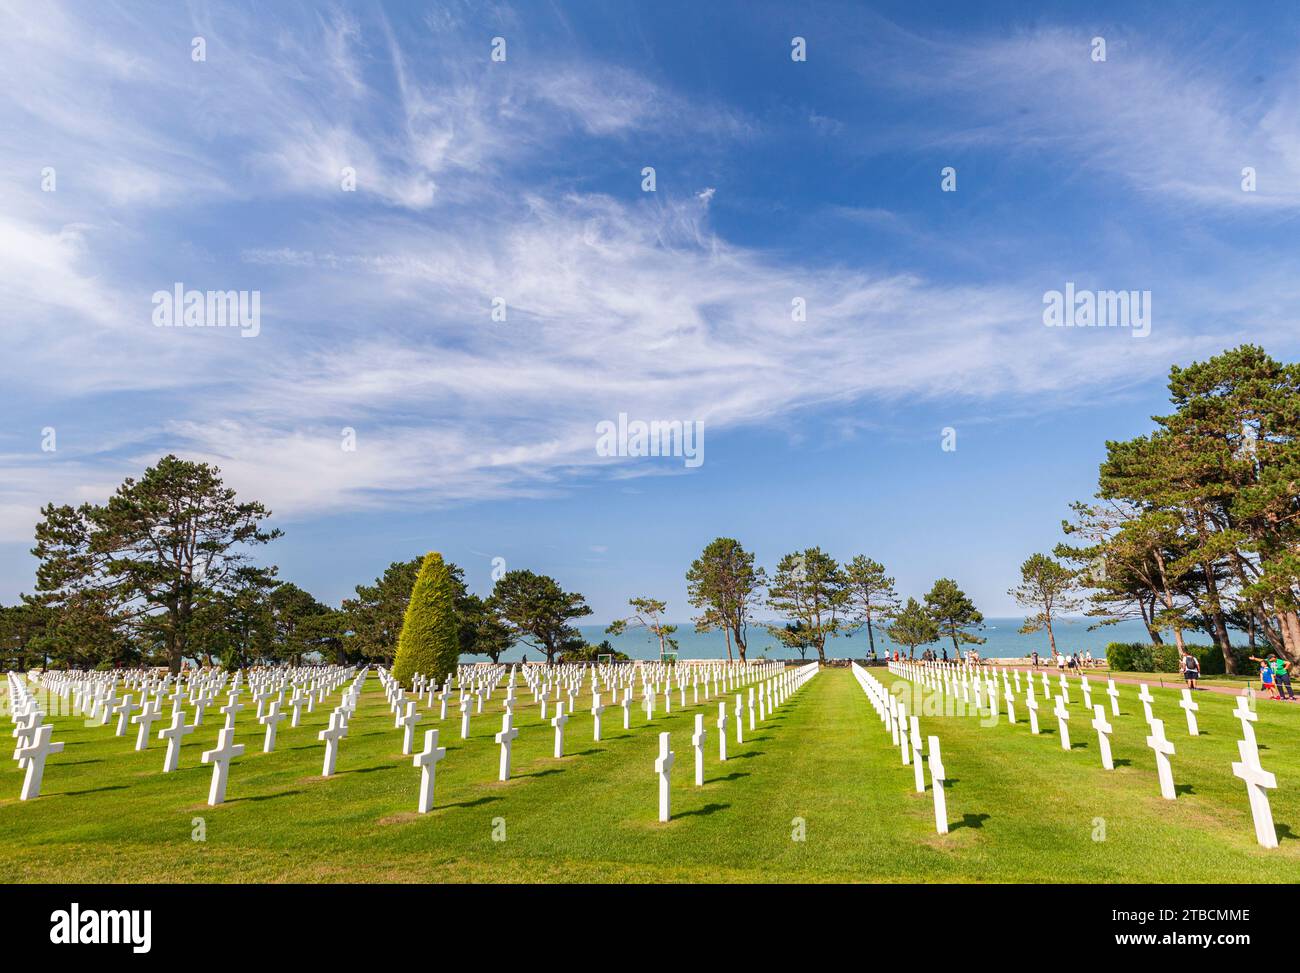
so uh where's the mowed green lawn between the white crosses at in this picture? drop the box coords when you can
[0,669,1300,882]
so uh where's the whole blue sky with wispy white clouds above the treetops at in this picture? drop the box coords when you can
[0,3,1300,620]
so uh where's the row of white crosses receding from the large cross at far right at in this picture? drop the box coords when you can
[889,661,1278,848]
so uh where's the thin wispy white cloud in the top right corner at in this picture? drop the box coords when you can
[859,25,1300,212]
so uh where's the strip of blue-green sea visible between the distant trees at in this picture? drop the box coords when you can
[467,618,1159,662]
